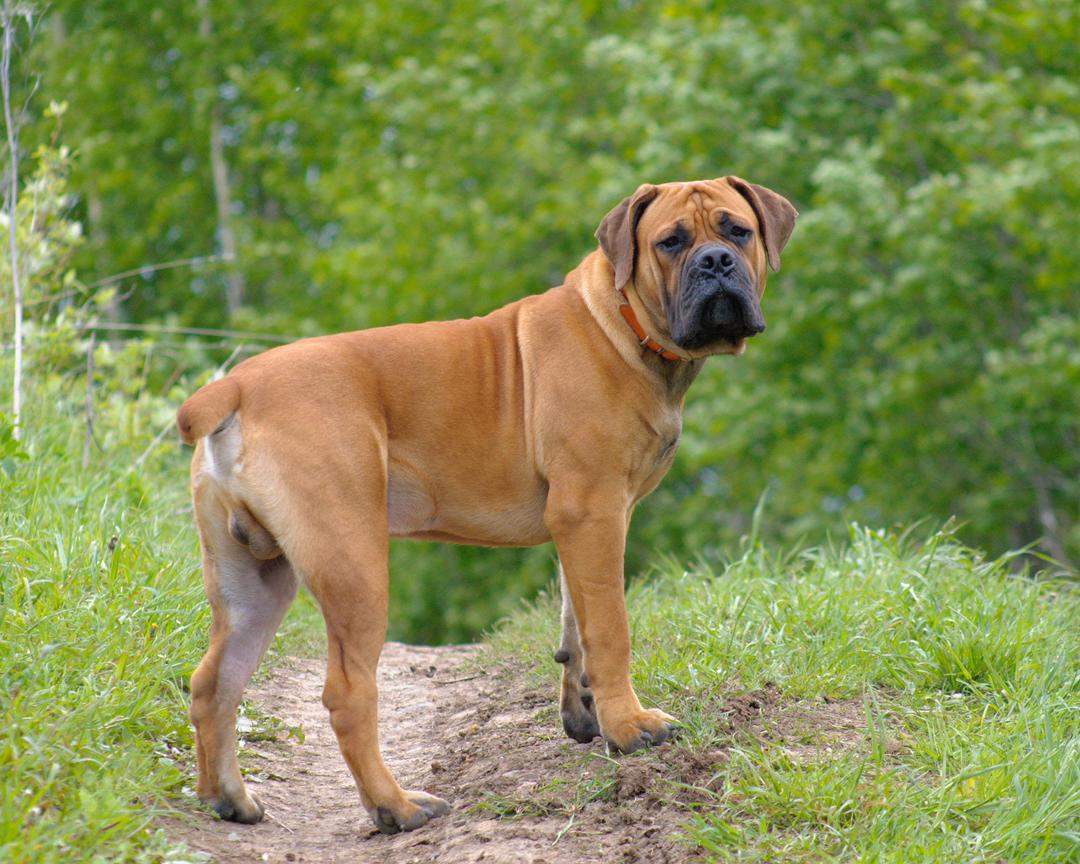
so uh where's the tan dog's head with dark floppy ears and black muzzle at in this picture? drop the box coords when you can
[596,176,798,357]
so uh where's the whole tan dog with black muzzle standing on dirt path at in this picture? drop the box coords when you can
[178,177,796,833]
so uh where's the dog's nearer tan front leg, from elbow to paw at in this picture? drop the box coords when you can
[544,486,673,753]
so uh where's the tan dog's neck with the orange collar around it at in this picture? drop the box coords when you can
[567,249,705,403]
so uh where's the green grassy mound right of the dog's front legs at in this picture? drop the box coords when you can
[490,527,1080,863]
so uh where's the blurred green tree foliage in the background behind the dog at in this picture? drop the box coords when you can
[14,0,1080,640]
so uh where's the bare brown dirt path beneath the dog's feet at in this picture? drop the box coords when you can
[161,643,865,864]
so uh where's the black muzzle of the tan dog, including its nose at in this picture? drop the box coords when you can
[672,243,765,348]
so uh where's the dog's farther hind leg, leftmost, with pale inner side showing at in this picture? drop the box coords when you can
[190,481,297,822]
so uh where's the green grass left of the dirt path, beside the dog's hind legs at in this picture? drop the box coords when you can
[0,360,320,864]
